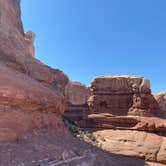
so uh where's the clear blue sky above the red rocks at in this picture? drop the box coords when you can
[21,0,166,93]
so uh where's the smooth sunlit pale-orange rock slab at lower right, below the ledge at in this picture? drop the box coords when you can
[94,130,166,164]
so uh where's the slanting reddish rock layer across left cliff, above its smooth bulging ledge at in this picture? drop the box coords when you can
[0,47,69,95]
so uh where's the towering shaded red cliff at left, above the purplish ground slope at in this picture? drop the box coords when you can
[0,0,68,142]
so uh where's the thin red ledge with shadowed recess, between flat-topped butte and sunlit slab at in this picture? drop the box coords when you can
[78,113,166,136]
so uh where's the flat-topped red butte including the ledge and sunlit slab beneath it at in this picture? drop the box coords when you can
[64,76,166,164]
